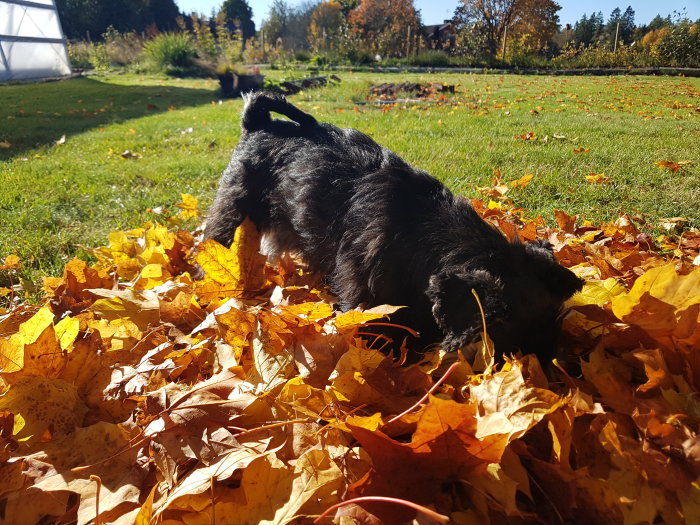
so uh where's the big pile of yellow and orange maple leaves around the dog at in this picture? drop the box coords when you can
[0,193,700,525]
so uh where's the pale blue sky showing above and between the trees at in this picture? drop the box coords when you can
[175,0,700,28]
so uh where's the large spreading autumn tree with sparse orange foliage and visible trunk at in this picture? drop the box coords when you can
[455,0,561,56]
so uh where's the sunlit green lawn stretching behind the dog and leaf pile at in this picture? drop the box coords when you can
[0,71,700,286]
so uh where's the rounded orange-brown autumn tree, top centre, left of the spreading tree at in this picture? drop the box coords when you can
[348,0,421,56]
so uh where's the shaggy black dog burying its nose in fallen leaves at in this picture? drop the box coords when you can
[205,92,582,359]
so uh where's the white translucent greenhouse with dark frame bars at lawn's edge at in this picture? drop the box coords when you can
[0,0,71,82]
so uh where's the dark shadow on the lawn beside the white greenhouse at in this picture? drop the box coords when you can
[0,77,221,161]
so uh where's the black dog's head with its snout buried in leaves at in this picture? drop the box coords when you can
[427,241,583,360]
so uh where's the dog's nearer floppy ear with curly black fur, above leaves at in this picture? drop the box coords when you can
[427,268,506,350]
